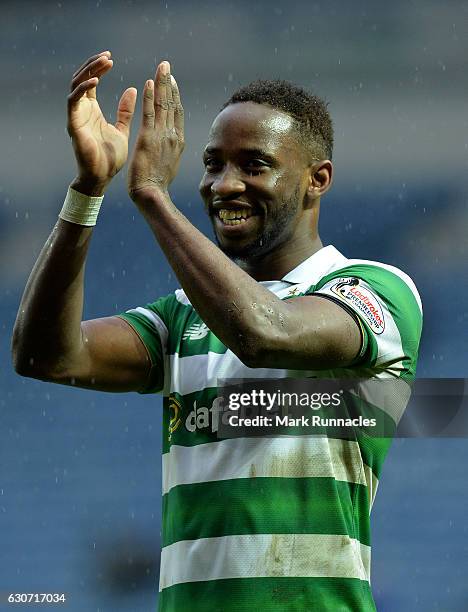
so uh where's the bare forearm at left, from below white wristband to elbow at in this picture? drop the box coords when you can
[12,219,92,378]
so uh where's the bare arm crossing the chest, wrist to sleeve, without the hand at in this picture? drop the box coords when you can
[137,203,361,370]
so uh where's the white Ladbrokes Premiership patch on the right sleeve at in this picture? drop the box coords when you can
[331,278,385,334]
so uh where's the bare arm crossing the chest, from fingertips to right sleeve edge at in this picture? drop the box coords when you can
[129,62,361,369]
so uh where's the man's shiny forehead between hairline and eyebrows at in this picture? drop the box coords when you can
[207,102,297,153]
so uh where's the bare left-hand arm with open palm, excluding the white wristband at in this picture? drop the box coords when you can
[12,52,150,391]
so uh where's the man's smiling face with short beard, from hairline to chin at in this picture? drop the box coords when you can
[200,102,316,260]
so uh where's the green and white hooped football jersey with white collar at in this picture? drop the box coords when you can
[121,246,422,612]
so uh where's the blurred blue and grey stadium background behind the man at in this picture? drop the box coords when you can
[0,0,468,612]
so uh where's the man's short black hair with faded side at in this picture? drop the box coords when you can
[221,79,333,159]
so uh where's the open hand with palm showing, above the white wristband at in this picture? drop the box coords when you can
[67,51,137,195]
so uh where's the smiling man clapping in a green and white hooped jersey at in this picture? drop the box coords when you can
[13,52,421,612]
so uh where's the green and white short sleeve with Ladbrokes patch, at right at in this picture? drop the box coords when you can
[311,264,422,378]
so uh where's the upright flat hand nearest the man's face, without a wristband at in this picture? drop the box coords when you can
[128,62,184,204]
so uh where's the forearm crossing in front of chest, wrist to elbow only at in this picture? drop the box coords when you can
[139,195,289,361]
